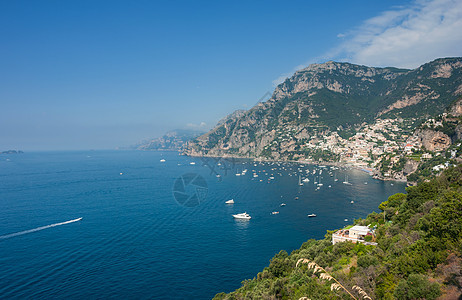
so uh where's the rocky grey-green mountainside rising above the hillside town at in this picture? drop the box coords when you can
[185,58,462,160]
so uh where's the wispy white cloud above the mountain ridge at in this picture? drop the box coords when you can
[334,0,462,68]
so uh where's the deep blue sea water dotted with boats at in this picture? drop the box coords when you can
[0,151,405,299]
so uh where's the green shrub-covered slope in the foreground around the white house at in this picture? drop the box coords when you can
[215,165,462,299]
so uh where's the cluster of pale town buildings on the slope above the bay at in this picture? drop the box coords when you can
[296,113,461,180]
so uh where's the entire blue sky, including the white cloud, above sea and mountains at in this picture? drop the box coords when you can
[0,0,462,151]
